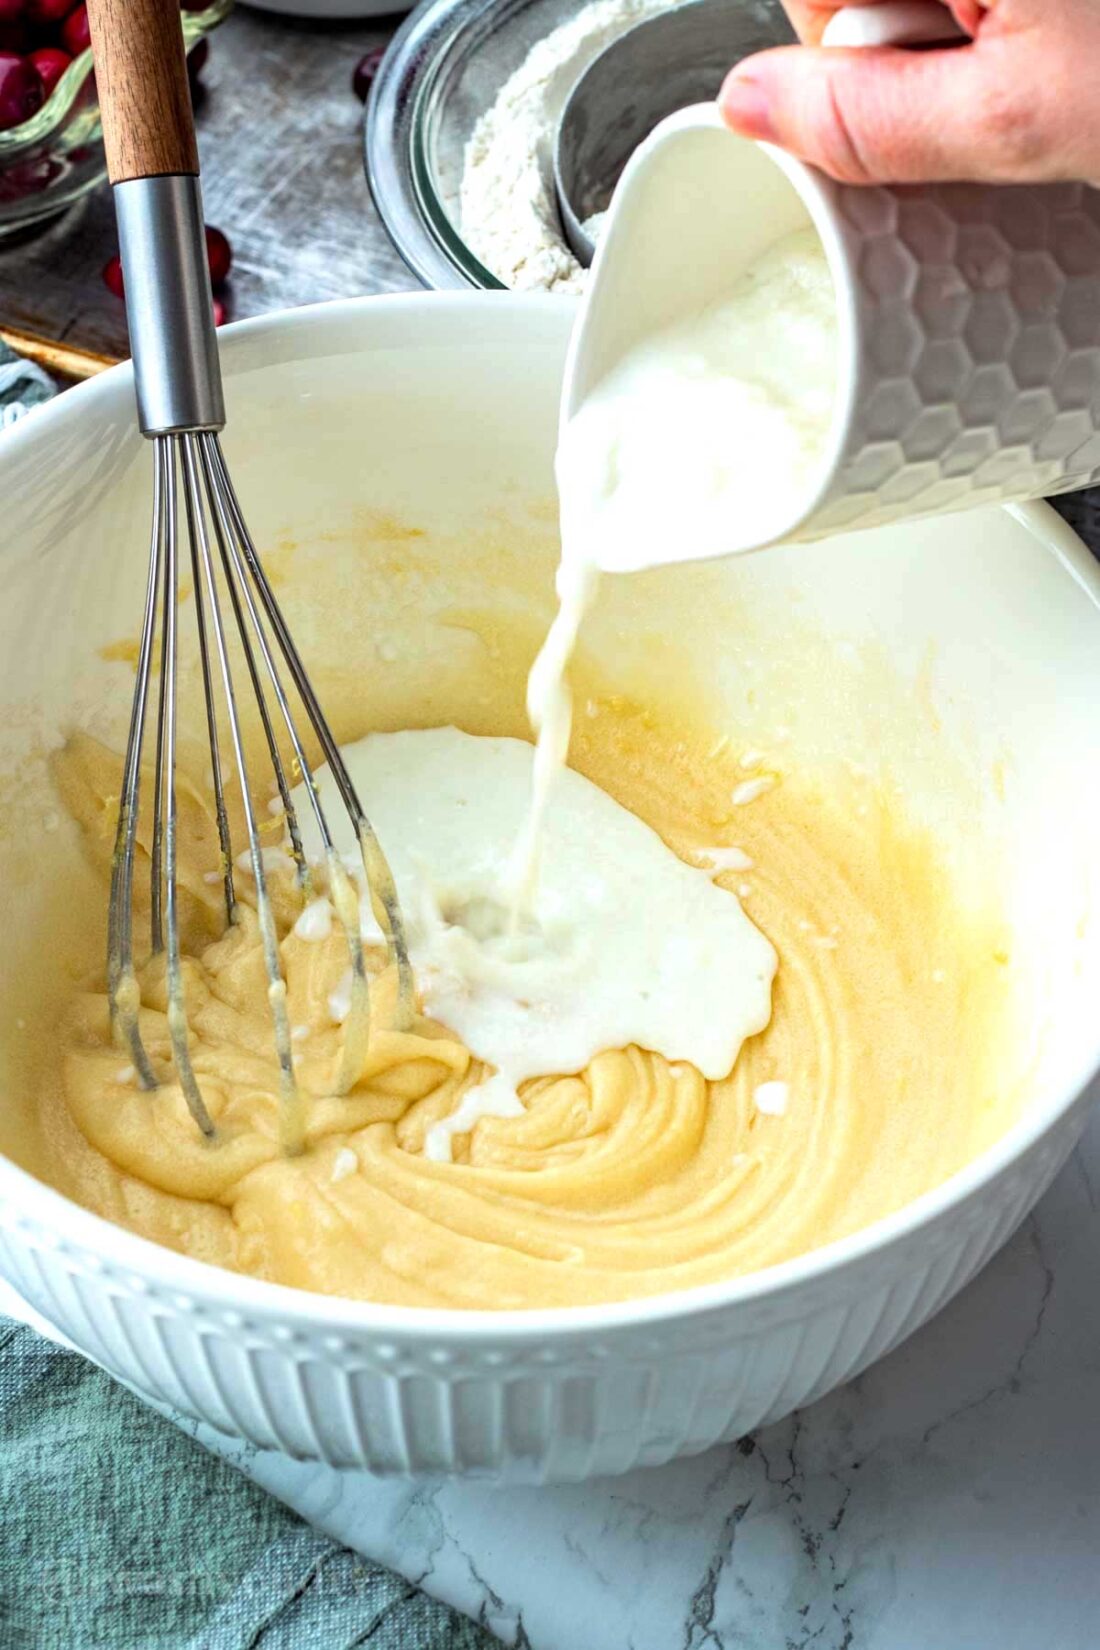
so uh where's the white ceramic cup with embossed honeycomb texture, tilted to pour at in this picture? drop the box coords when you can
[562,5,1100,559]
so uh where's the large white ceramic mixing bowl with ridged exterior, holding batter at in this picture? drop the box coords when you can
[0,294,1100,1482]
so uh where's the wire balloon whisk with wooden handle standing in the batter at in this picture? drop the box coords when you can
[87,0,412,1152]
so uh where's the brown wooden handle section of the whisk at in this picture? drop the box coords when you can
[87,0,198,183]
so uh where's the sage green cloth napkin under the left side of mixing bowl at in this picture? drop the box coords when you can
[0,342,500,1650]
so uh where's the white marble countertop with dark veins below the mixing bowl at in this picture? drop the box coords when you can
[8,1114,1100,1650]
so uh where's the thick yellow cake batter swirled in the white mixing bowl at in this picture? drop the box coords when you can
[38,617,1021,1308]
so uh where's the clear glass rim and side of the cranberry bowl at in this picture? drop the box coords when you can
[0,0,233,236]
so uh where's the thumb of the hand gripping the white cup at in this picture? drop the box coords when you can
[719,46,1051,183]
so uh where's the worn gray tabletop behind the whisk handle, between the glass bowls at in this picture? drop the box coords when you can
[0,5,417,355]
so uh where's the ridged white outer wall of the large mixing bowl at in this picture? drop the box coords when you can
[0,1096,1085,1483]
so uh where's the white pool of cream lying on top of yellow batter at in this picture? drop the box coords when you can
[295,728,775,1160]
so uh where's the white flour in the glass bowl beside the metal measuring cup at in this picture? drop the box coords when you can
[458,0,670,292]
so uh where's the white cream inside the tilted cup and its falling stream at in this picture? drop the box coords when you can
[510,229,836,932]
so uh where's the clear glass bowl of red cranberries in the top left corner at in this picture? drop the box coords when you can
[0,0,233,236]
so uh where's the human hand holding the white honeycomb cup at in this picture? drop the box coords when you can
[719,0,1100,185]
